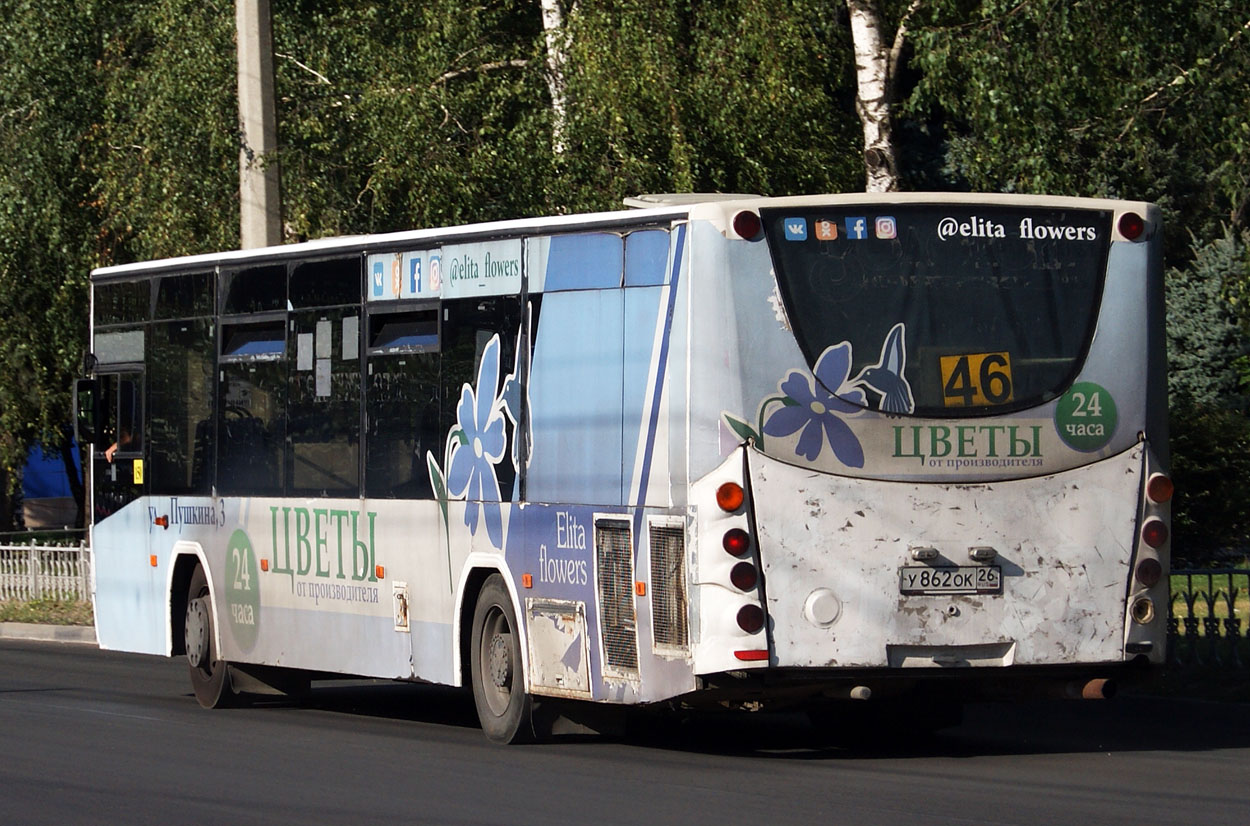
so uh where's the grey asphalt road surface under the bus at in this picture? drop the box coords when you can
[0,640,1250,826]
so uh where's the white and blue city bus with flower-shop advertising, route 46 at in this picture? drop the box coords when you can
[75,194,1171,742]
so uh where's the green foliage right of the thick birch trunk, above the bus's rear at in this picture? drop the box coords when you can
[909,0,1250,257]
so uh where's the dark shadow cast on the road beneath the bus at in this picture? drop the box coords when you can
[243,681,1250,760]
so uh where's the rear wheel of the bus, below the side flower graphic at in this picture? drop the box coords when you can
[469,574,534,744]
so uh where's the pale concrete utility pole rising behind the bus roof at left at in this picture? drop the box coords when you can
[235,0,283,250]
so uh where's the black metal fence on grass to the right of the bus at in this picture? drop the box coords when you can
[1168,567,1250,670]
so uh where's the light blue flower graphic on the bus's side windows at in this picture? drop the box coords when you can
[448,335,508,547]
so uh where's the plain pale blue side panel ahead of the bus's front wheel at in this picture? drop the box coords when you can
[91,499,168,655]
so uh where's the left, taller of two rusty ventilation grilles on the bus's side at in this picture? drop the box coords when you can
[595,519,638,672]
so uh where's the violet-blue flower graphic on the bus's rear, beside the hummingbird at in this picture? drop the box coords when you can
[764,341,865,467]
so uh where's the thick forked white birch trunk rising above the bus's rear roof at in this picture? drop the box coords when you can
[846,0,921,192]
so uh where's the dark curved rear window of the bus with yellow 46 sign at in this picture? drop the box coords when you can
[760,204,1111,417]
